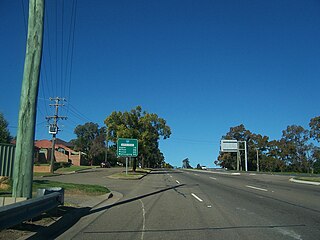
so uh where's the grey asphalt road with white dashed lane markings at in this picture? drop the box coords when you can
[59,170,320,240]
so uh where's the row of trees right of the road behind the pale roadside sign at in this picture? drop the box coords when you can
[215,116,320,173]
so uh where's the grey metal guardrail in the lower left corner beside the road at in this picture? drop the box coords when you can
[0,192,63,230]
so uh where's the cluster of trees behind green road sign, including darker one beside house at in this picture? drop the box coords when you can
[71,106,171,170]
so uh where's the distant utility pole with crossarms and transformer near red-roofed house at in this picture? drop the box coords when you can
[46,97,67,173]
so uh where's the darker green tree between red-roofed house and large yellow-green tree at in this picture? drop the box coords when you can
[72,122,106,165]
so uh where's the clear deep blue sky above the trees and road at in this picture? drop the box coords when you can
[0,0,320,167]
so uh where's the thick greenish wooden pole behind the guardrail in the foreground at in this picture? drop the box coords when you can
[12,0,44,198]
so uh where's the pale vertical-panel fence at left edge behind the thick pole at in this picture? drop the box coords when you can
[0,143,16,177]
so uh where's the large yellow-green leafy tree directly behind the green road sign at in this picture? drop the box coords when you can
[104,106,171,170]
